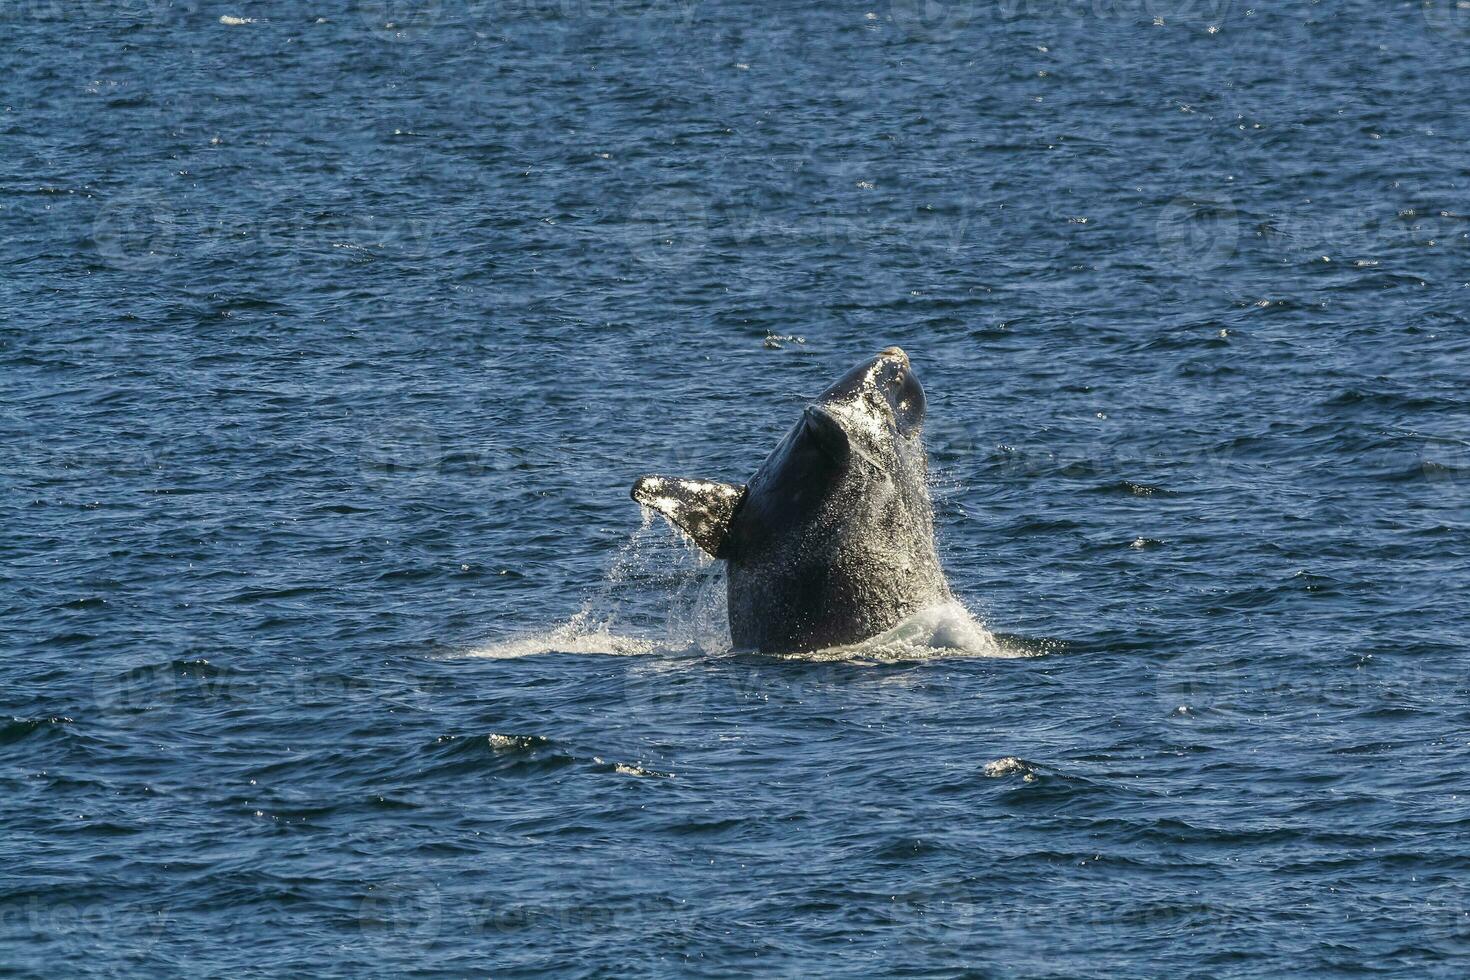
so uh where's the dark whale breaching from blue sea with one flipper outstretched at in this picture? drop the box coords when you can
[632,347,953,654]
